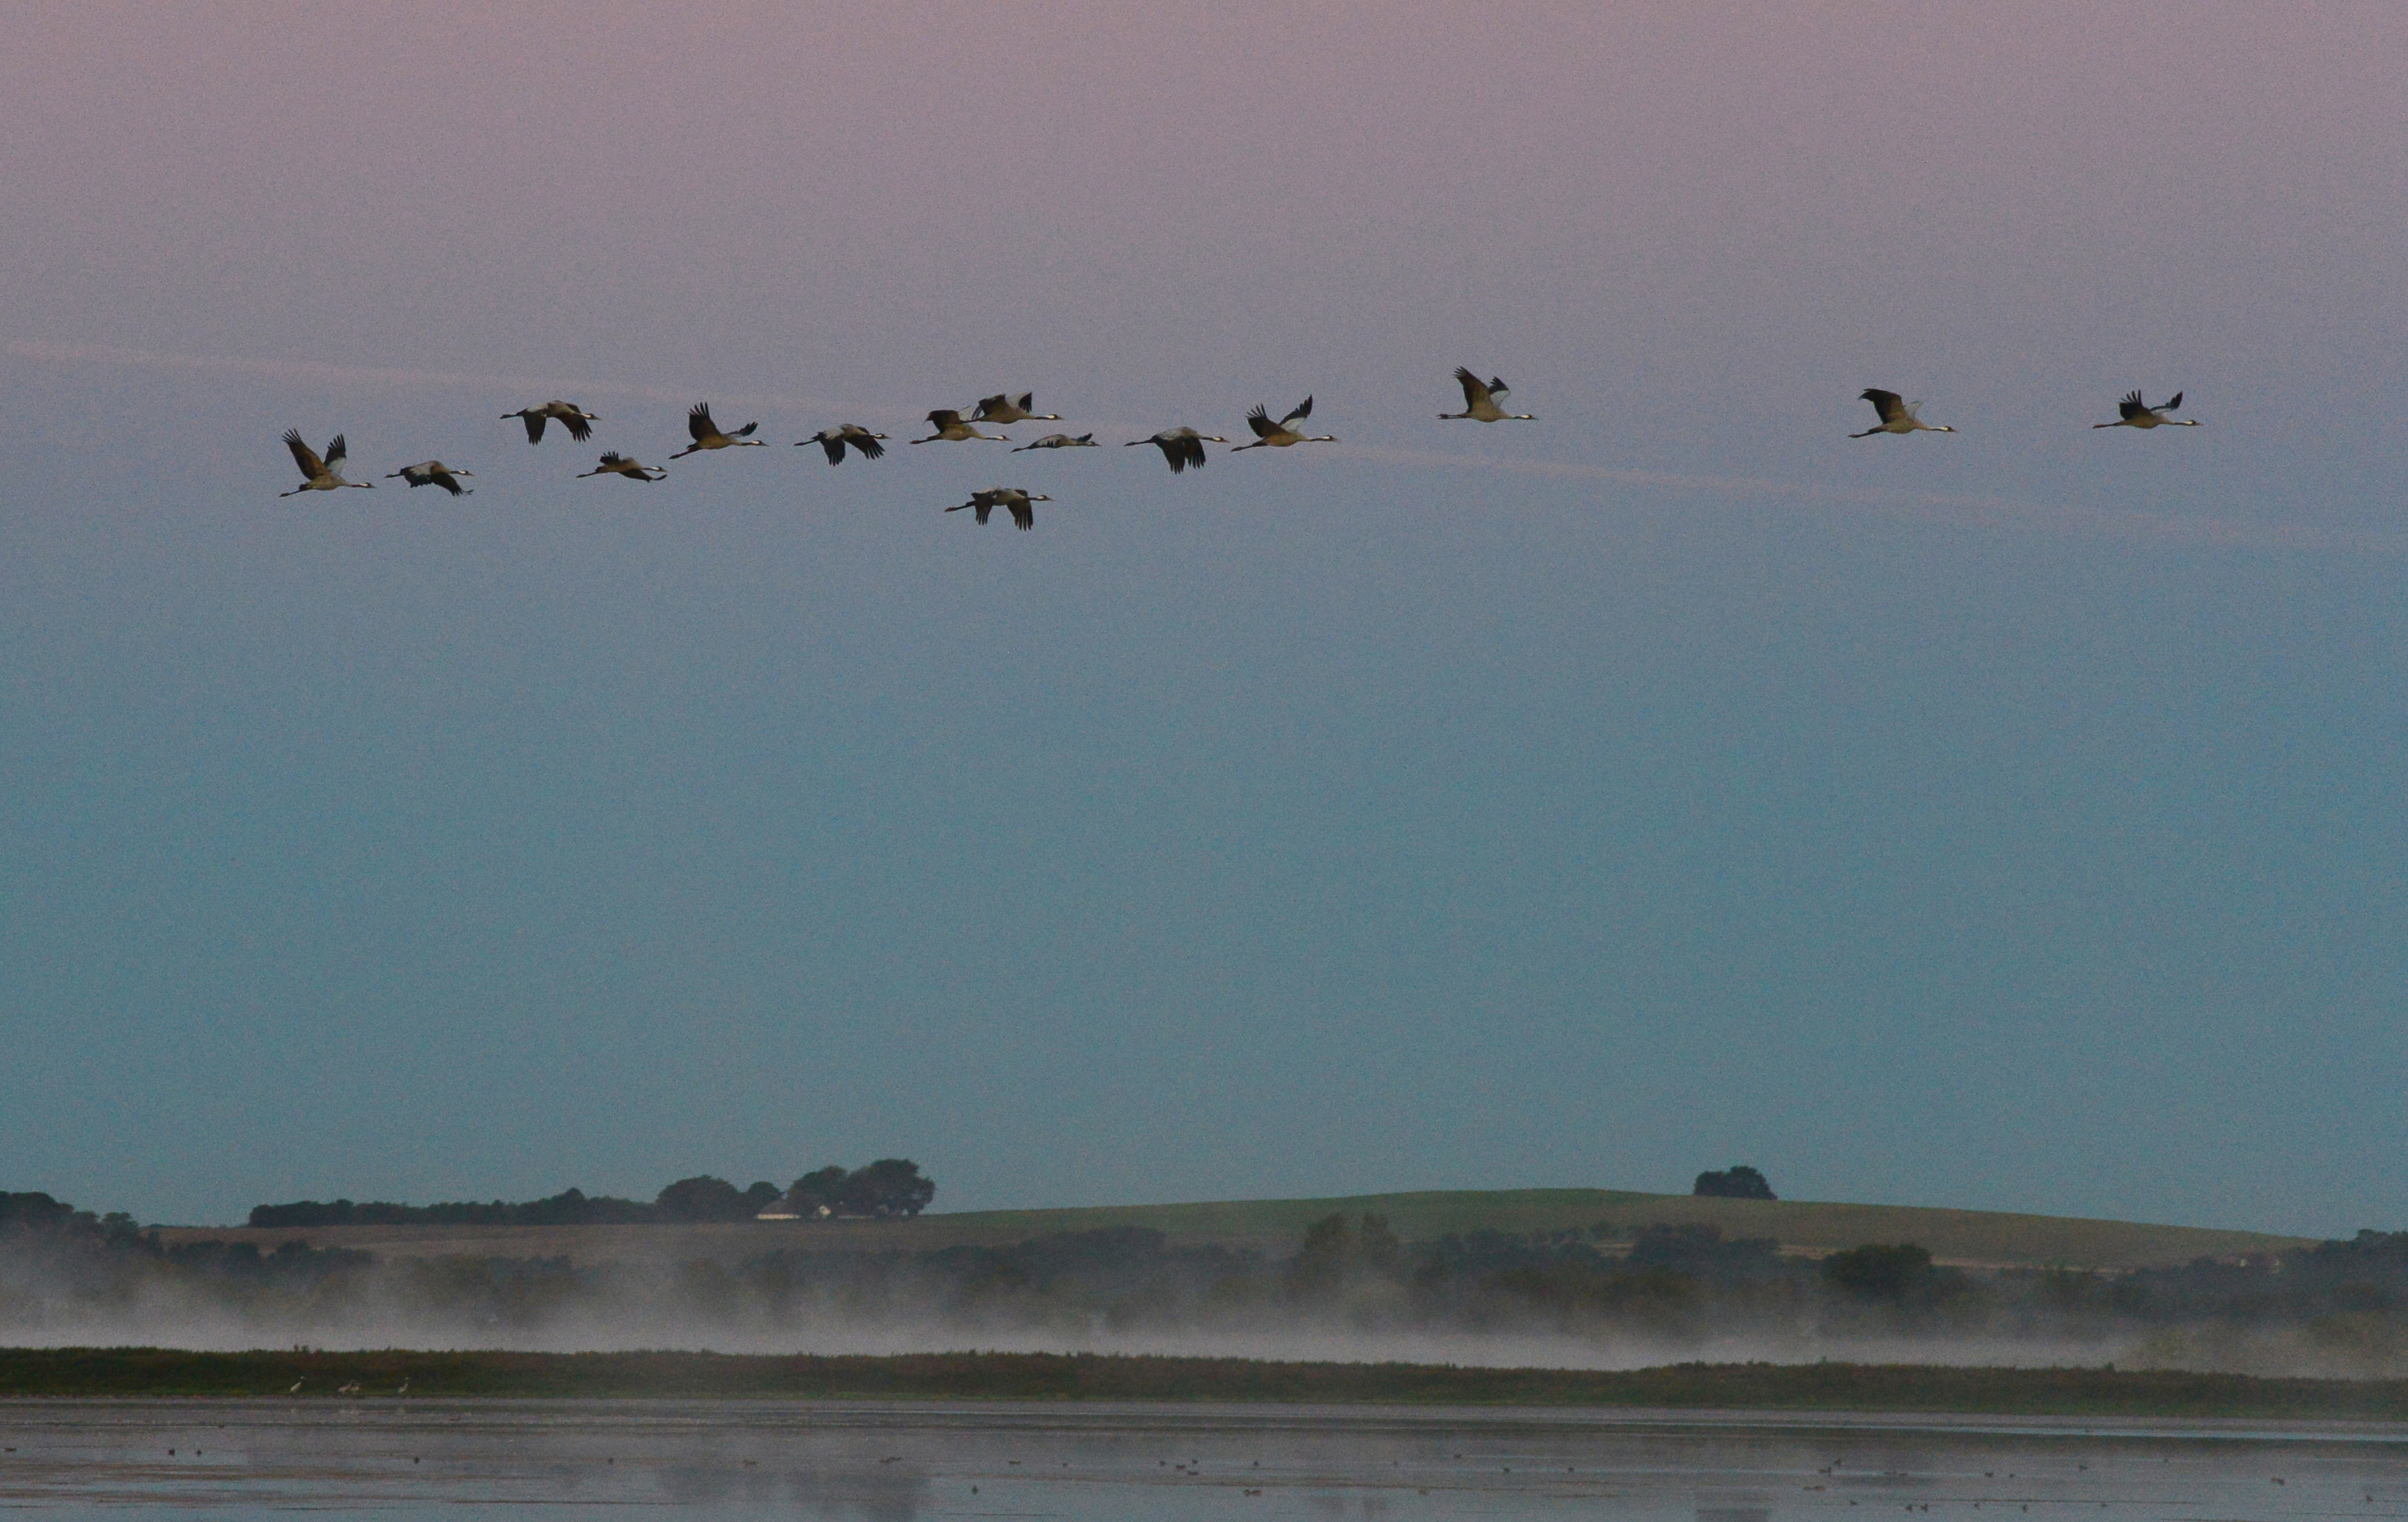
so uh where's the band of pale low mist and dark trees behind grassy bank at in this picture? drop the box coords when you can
[0,1197,2408,1375]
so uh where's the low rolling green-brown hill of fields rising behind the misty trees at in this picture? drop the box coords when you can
[161,1190,2312,1269]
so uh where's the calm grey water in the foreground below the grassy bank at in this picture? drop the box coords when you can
[0,1397,2408,1522]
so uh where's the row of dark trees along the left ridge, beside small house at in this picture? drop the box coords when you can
[248,1158,937,1228]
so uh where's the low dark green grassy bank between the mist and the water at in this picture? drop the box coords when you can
[0,1349,2408,1421]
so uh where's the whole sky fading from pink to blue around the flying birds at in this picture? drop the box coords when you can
[0,5,2408,1233]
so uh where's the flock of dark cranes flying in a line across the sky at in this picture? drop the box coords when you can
[279,366,2199,527]
